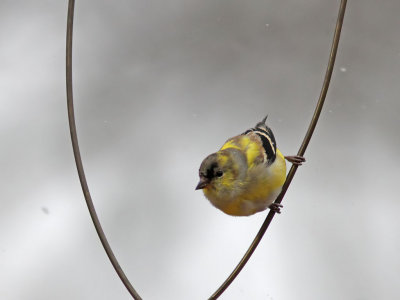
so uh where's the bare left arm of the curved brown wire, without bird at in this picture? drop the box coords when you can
[66,0,142,300]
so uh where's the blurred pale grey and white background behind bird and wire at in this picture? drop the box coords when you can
[0,0,400,300]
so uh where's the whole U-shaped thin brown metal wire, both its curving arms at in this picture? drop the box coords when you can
[66,0,347,300]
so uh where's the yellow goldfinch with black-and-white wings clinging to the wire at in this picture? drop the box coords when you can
[196,117,305,216]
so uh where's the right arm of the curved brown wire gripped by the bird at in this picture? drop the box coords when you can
[209,0,347,300]
